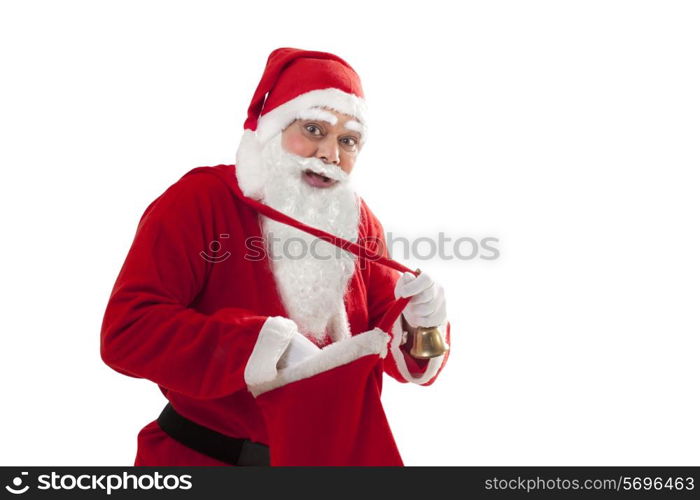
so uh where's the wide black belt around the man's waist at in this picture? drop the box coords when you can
[158,403,270,466]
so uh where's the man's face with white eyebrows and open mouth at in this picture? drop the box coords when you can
[282,108,362,188]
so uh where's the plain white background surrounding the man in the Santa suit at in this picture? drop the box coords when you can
[0,0,700,465]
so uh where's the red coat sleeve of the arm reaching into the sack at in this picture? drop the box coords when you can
[100,174,267,399]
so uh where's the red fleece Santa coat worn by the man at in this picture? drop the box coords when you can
[101,165,450,465]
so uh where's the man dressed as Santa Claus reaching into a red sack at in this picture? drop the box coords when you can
[101,48,450,465]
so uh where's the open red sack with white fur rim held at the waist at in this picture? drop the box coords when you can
[249,328,403,466]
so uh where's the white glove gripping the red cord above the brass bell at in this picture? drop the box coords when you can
[394,272,447,327]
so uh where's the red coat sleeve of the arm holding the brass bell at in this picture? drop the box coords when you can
[360,200,442,385]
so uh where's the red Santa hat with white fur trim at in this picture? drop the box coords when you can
[236,47,367,198]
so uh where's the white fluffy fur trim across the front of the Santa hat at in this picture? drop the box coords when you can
[256,88,367,144]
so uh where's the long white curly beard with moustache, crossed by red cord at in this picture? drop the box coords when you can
[261,133,359,345]
